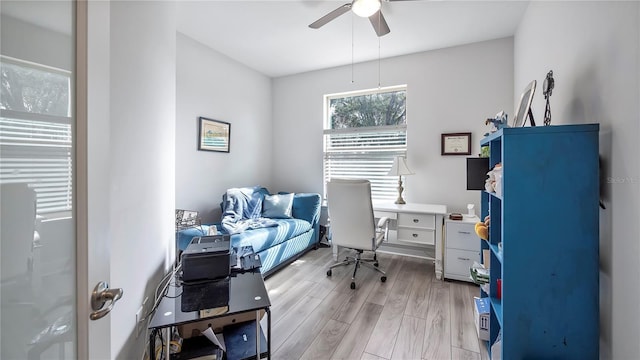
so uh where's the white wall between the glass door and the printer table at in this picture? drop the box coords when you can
[105,1,176,359]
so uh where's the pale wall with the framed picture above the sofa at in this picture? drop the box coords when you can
[175,34,272,222]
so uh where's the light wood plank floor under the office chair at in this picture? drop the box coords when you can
[266,248,488,360]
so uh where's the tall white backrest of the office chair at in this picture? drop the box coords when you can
[327,179,376,250]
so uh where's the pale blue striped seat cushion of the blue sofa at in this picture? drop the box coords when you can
[231,219,311,253]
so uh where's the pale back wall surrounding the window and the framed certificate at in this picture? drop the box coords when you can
[273,38,513,212]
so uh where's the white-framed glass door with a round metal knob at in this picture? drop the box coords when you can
[0,0,111,359]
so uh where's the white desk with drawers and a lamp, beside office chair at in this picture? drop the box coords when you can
[333,201,447,279]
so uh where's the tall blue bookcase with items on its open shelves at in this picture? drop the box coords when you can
[480,124,599,360]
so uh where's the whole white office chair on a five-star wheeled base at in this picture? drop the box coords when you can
[327,179,389,289]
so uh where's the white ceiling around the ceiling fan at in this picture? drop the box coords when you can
[178,0,528,77]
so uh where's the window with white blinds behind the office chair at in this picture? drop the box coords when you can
[323,86,407,200]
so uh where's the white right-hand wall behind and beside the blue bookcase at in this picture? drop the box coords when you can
[514,2,640,359]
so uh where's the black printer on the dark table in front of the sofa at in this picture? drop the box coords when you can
[180,235,231,283]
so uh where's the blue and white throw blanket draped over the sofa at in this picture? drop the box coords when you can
[222,186,277,234]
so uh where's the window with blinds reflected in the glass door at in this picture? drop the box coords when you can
[0,56,73,214]
